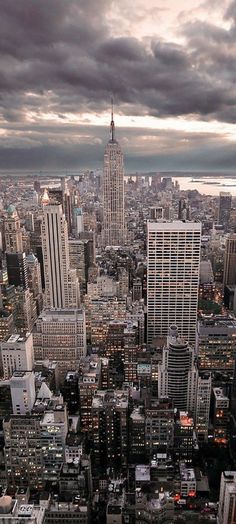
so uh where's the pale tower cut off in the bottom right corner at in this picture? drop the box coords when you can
[217,471,236,524]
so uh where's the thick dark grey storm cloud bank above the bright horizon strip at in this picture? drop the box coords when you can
[0,0,236,118]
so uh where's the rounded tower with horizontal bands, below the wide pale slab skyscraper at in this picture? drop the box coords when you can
[158,325,198,414]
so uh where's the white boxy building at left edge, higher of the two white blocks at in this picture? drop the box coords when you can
[1,333,34,379]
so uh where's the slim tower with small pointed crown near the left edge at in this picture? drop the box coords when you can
[4,205,23,253]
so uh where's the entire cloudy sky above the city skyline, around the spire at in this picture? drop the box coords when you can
[0,0,236,172]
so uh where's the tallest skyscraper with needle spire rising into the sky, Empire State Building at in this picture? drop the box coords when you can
[103,106,125,246]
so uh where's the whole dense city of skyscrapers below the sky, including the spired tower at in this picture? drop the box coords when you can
[0,115,236,524]
